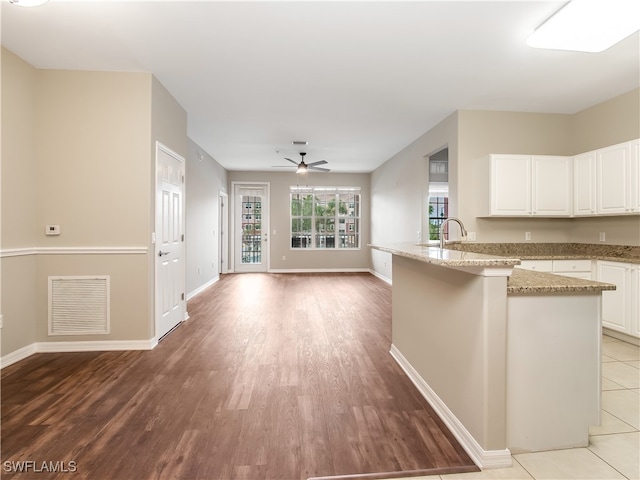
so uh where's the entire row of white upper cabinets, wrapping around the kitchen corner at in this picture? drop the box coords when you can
[474,139,640,217]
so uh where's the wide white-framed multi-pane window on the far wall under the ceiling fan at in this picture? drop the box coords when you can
[290,187,360,249]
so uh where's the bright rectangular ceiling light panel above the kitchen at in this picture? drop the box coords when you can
[527,0,640,53]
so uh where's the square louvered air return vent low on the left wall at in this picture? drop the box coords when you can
[49,275,110,335]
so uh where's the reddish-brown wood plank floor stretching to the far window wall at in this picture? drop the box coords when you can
[1,274,477,480]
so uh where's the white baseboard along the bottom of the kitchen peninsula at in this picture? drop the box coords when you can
[390,345,512,469]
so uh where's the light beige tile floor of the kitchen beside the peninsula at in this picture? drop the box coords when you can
[390,336,640,480]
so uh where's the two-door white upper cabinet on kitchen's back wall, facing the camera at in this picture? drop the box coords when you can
[476,154,573,217]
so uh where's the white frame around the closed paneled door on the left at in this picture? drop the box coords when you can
[152,141,189,342]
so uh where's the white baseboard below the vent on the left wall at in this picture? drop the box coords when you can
[0,338,158,369]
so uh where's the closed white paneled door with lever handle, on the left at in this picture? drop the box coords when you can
[155,143,186,339]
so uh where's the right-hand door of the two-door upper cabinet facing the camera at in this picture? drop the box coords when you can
[531,155,573,217]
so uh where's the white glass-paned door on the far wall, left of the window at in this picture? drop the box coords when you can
[233,183,269,272]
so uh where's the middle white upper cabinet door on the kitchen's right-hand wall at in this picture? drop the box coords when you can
[596,143,631,214]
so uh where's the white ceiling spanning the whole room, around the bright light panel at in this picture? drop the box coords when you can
[1,0,640,172]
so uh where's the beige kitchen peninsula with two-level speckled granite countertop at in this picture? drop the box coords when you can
[371,243,615,468]
